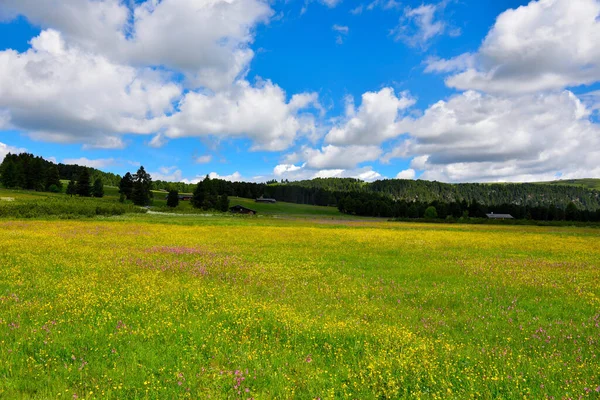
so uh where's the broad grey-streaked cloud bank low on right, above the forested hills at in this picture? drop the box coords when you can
[390,91,600,181]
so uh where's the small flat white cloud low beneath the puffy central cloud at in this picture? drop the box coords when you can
[286,145,382,169]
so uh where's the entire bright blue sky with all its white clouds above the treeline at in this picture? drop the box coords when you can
[0,0,600,182]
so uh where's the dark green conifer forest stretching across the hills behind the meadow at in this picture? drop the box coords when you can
[0,153,600,221]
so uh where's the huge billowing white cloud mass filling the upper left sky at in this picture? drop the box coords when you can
[0,0,322,150]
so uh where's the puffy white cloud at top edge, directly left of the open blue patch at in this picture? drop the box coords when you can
[132,0,273,89]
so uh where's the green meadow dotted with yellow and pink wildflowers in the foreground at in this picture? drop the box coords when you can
[0,216,600,399]
